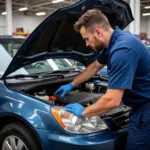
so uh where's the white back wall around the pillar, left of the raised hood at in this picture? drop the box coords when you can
[0,12,47,34]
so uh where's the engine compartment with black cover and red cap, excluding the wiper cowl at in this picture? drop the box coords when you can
[27,80,107,106]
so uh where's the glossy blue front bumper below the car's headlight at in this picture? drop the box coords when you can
[36,129,127,150]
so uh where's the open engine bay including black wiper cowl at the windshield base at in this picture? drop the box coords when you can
[7,71,107,106]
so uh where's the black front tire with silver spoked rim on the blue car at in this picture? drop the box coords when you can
[0,122,42,150]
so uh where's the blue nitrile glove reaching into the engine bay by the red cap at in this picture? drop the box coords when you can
[54,83,74,97]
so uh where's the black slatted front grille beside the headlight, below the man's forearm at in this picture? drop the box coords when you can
[105,105,131,128]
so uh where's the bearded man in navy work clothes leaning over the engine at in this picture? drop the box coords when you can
[55,9,150,150]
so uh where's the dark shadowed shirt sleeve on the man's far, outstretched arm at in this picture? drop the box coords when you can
[97,49,108,65]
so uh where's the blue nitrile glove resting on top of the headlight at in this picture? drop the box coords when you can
[66,103,84,117]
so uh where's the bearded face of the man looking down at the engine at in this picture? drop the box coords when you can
[80,26,104,52]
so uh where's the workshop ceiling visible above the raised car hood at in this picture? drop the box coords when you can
[0,0,150,15]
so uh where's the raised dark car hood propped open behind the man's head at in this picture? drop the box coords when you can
[2,0,133,79]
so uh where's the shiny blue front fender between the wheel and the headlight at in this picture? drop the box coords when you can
[0,82,62,132]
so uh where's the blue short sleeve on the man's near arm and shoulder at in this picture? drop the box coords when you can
[108,48,139,90]
